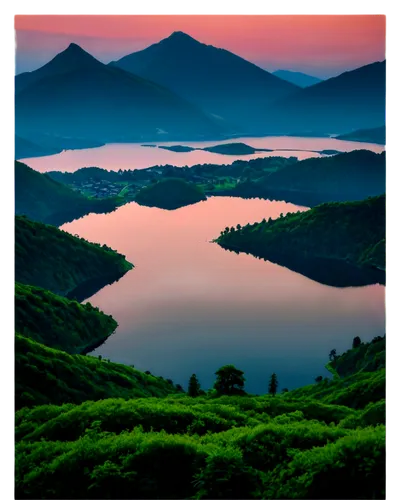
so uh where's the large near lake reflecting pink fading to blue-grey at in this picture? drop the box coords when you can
[61,196,385,394]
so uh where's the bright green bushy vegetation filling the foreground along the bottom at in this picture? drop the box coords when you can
[14,337,390,499]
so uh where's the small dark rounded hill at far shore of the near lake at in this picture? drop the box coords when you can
[135,178,207,210]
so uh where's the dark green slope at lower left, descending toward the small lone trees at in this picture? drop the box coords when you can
[14,333,176,408]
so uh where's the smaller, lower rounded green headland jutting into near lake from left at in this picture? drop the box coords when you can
[13,282,117,354]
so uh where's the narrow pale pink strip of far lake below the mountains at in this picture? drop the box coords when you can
[22,137,385,172]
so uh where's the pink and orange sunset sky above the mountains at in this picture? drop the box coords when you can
[13,12,388,78]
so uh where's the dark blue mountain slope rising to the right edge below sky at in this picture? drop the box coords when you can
[268,61,387,134]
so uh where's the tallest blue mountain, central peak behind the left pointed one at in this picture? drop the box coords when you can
[110,31,299,135]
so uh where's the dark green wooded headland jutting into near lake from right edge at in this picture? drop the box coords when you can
[216,195,386,269]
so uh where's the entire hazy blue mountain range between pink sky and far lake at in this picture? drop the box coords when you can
[15,32,386,145]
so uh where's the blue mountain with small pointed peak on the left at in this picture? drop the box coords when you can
[15,44,225,142]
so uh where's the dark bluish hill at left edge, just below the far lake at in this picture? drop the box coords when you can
[14,161,119,225]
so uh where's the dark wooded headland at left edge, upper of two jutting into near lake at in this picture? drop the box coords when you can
[14,216,133,300]
